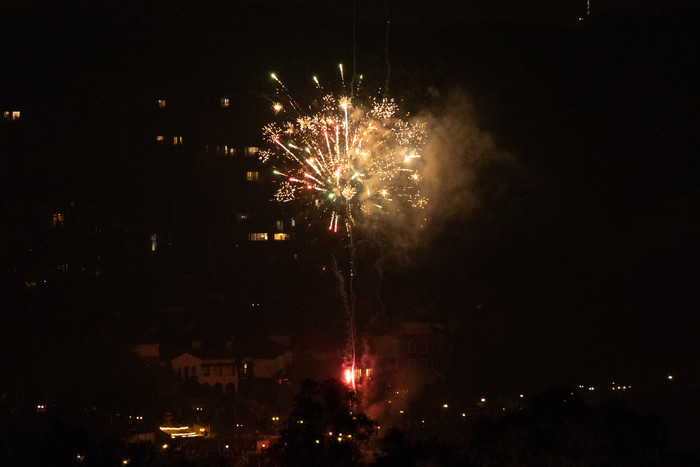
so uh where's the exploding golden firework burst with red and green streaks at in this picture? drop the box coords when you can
[261,66,427,235]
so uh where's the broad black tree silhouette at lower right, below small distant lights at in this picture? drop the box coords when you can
[471,389,666,467]
